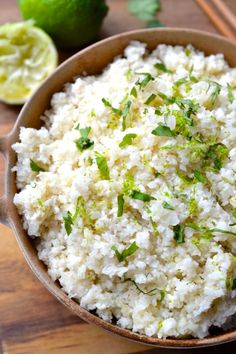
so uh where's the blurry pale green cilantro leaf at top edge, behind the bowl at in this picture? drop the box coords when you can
[128,0,161,20]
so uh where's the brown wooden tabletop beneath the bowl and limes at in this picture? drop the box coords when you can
[0,0,236,354]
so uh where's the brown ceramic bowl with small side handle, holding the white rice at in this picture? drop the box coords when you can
[0,28,236,348]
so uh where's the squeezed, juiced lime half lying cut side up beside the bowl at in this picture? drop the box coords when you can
[0,21,58,104]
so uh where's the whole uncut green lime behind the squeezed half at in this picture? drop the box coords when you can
[18,0,108,48]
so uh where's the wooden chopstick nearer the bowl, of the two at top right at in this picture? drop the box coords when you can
[196,0,236,40]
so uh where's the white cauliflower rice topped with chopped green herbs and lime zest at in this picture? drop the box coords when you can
[13,42,236,338]
